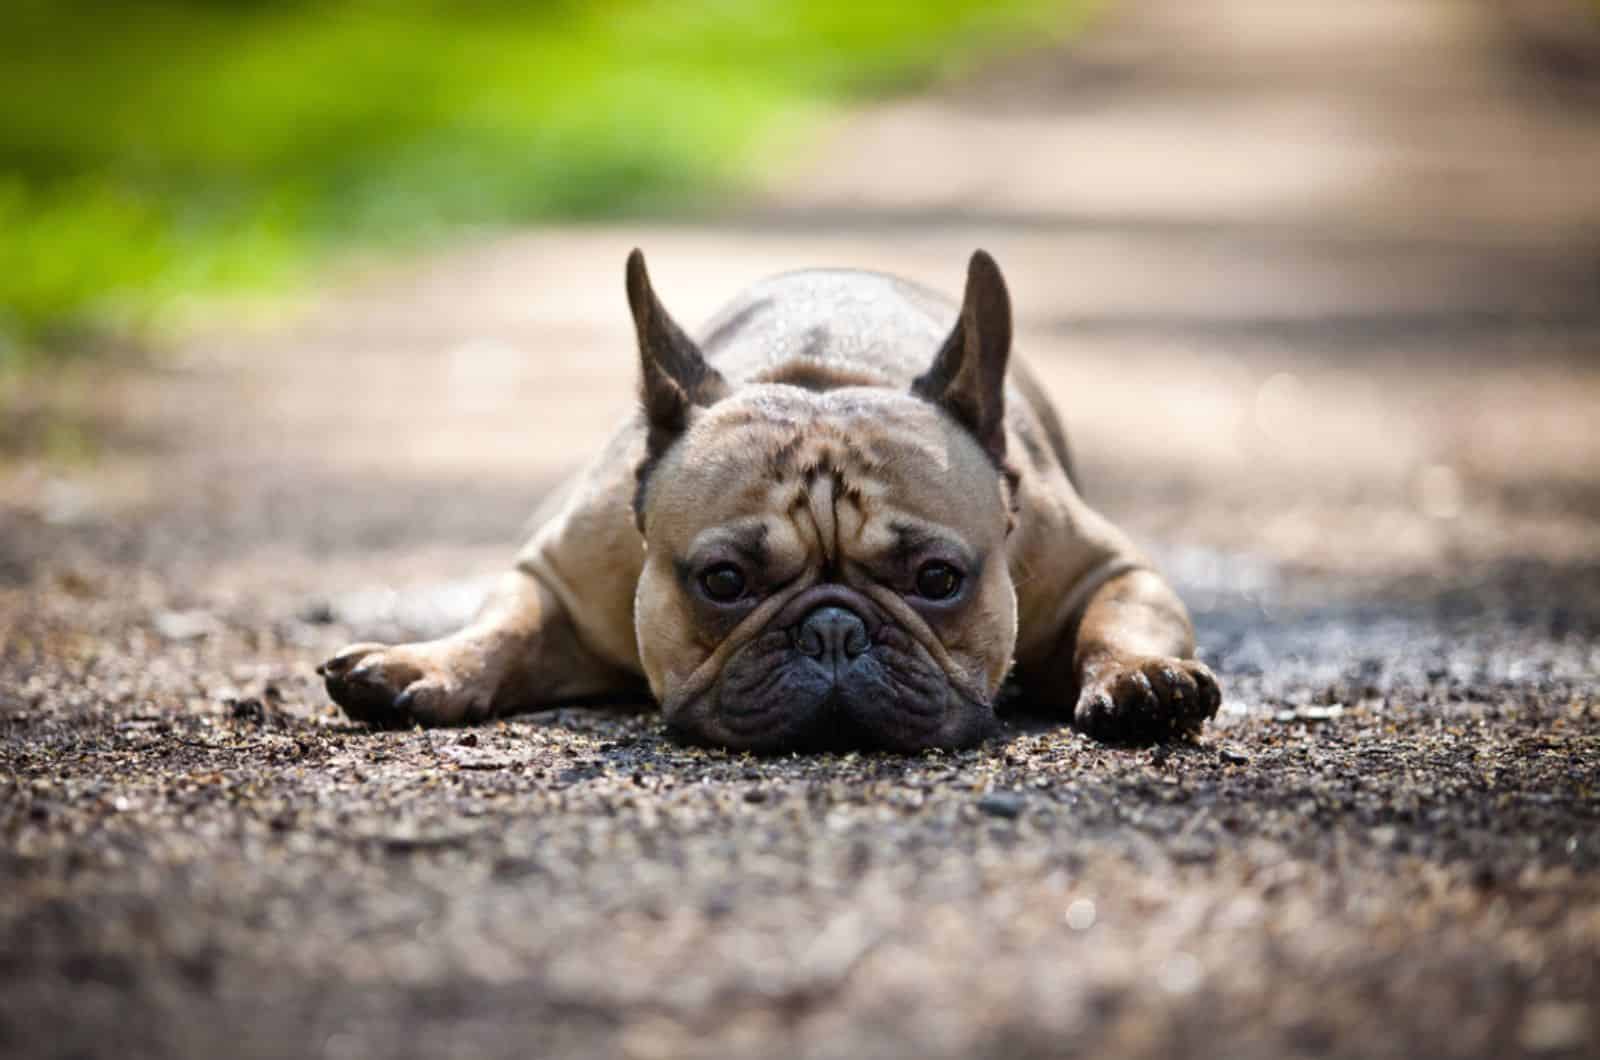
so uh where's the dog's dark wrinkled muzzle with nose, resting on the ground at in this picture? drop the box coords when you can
[664,583,994,751]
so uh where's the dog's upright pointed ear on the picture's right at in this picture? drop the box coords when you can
[912,250,1011,461]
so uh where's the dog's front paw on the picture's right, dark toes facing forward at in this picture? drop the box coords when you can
[1072,655,1222,743]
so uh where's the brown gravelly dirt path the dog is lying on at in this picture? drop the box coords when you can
[0,0,1600,1057]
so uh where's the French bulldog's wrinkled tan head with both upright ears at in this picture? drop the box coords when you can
[627,251,1016,751]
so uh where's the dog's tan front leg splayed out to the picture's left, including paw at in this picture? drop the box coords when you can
[317,570,627,725]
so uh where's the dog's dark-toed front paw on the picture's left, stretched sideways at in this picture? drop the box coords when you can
[317,640,491,727]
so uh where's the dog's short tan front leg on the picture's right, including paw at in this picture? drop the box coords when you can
[1072,570,1222,743]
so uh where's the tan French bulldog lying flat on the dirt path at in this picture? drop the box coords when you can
[318,250,1221,753]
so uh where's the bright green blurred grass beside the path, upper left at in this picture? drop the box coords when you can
[0,0,1090,360]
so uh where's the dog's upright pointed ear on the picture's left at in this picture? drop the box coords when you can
[627,248,728,436]
